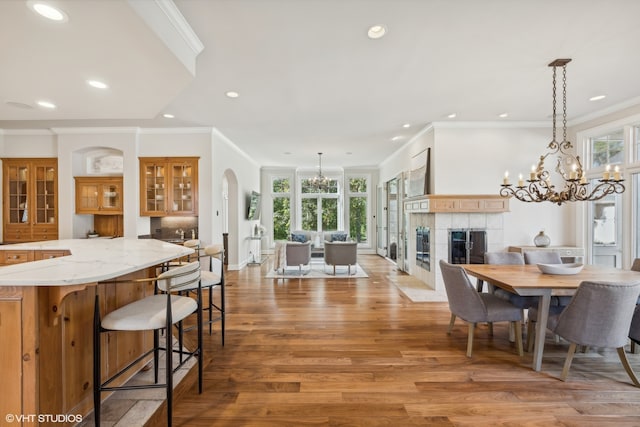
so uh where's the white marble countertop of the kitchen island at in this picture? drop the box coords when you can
[0,237,193,286]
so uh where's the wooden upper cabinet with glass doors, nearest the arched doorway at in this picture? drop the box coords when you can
[140,157,198,217]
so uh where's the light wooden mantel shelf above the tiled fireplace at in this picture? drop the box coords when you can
[404,194,509,213]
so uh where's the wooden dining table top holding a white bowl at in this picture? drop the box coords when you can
[463,264,640,295]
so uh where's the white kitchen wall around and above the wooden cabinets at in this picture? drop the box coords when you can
[0,127,260,268]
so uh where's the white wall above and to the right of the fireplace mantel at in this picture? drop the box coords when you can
[380,123,576,249]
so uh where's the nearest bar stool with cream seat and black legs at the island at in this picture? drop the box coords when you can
[93,261,203,427]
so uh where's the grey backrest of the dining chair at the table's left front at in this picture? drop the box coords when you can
[440,259,487,321]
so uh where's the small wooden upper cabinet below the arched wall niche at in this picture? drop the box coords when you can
[75,176,123,215]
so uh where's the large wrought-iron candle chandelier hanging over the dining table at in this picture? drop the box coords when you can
[500,59,624,206]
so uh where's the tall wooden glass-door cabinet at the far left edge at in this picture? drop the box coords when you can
[2,159,58,243]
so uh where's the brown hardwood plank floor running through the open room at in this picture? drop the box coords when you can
[174,255,640,427]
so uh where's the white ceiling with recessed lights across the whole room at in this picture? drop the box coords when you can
[0,0,640,168]
